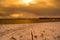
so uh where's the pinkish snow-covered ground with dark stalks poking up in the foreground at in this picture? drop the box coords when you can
[0,22,60,40]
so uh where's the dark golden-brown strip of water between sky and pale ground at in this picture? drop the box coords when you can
[0,18,60,24]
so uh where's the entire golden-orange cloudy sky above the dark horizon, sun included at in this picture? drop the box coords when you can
[0,0,60,18]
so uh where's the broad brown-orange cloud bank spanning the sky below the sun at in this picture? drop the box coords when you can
[0,0,60,17]
